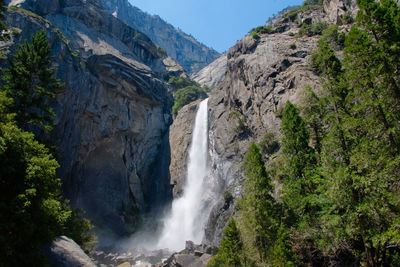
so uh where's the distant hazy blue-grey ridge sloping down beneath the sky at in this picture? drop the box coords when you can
[101,0,220,73]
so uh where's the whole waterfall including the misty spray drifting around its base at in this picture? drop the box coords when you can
[119,99,223,255]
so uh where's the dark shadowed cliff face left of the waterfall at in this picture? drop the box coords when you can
[6,0,176,239]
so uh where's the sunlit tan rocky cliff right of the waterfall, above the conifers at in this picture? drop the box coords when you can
[200,0,355,245]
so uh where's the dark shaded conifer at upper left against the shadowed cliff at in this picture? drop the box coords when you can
[3,30,63,132]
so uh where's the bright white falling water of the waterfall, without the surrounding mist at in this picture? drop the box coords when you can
[157,99,208,250]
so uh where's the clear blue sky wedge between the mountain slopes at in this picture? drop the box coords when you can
[129,0,303,52]
